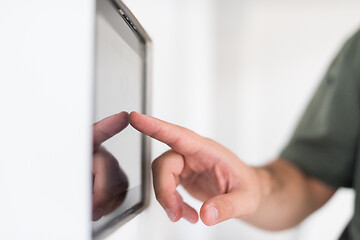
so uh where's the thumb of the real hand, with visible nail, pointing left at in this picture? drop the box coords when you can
[200,190,259,226]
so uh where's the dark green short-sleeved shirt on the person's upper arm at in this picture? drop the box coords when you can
[280,28,360,240]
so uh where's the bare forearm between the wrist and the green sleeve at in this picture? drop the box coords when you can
[244,159,336,231]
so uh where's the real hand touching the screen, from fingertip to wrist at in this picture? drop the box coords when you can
[129,112,262,226]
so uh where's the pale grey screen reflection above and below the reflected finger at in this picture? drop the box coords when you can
[95,7,143,188]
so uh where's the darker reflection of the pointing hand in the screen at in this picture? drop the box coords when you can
[92,112,129,221]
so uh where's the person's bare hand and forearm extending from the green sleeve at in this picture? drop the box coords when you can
[129,112,336,231]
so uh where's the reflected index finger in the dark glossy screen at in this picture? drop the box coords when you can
[93,112,129,151]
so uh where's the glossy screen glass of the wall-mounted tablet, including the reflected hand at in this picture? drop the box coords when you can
[93,1,144,230]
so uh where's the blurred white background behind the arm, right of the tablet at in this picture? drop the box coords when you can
[107,0,360,240]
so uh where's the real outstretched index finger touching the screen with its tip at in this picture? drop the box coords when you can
[129,112,201,155]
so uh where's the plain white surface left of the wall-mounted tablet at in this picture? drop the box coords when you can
[0,0,94,240]
